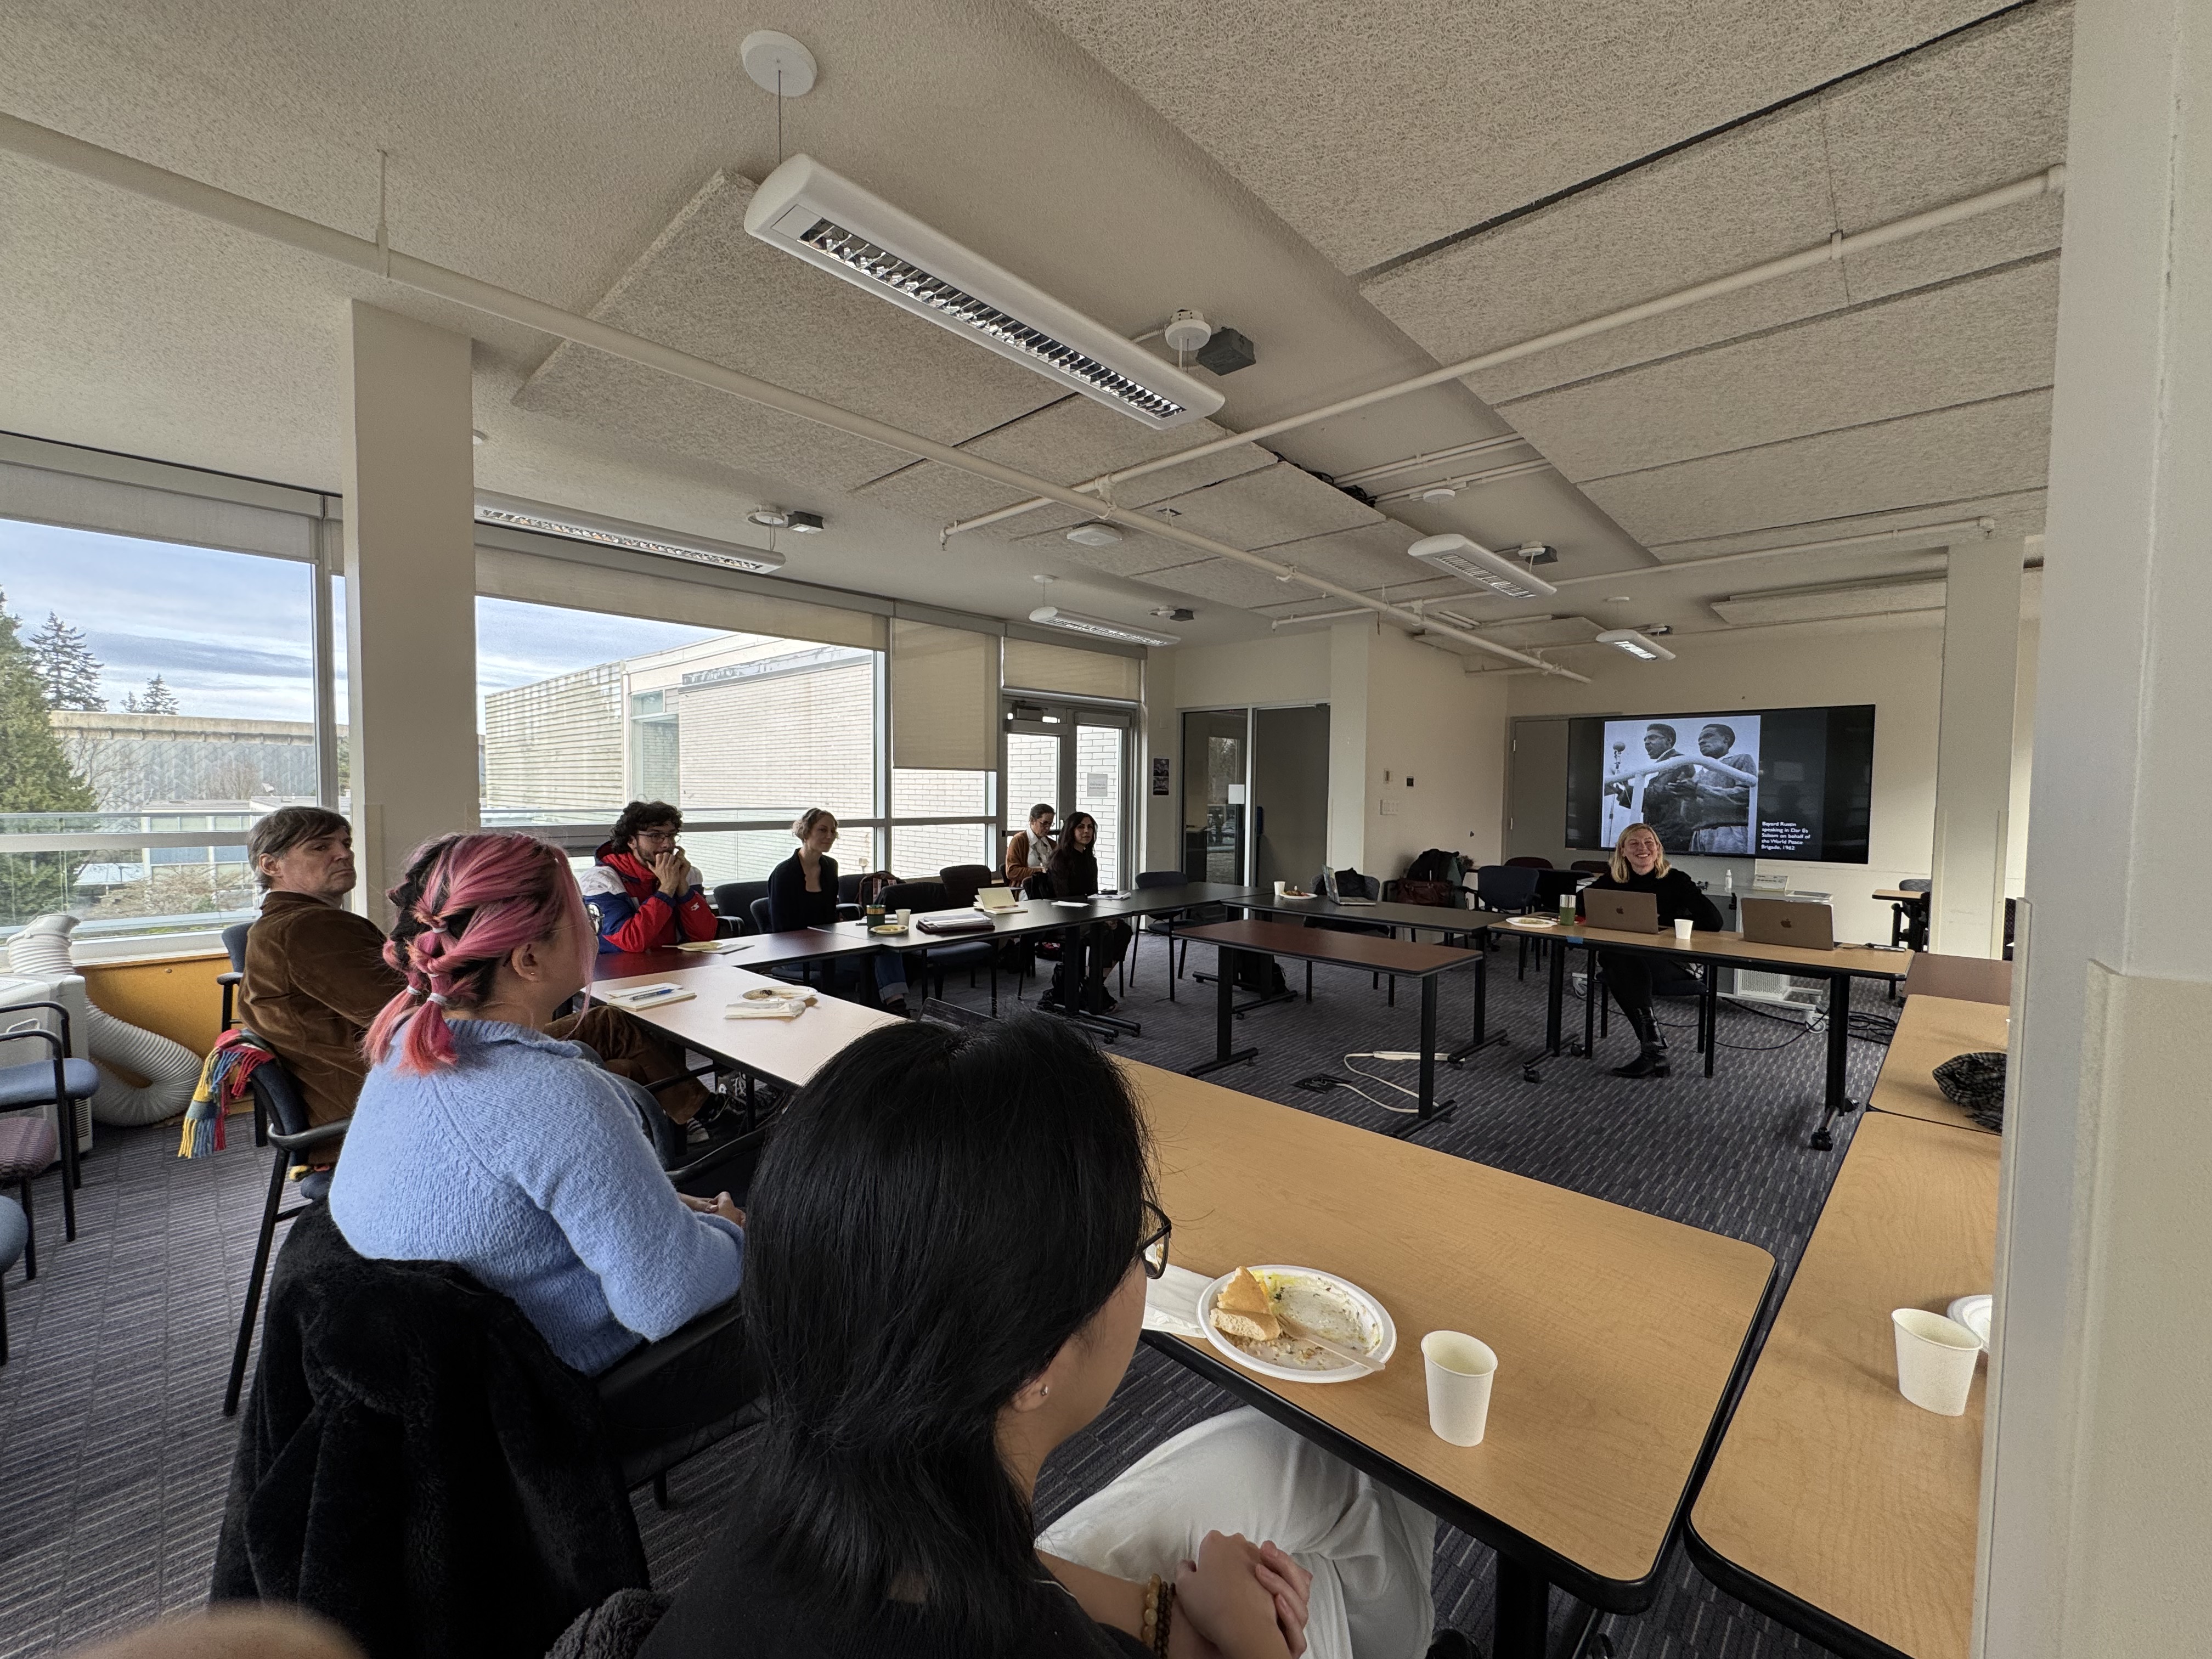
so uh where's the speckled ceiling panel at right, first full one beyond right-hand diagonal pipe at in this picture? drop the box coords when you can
[1513,259,2059,482]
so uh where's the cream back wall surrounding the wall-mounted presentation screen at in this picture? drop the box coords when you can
[1500,611,2037,940]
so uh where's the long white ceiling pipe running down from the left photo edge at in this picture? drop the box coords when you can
[0,113,1586,681]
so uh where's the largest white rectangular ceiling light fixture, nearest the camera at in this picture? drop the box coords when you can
[746,155,1221,427]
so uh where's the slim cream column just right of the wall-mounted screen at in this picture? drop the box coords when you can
[1929,542,2026,956]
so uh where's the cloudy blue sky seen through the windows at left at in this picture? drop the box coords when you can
[0,517,716,721]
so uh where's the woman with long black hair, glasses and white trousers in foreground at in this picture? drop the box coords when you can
[639,1018,1436,1659]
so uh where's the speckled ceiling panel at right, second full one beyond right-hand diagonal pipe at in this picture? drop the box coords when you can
[1584,392,2051,546]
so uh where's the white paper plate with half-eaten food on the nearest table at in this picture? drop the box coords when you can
[1199,1263,1398,1383]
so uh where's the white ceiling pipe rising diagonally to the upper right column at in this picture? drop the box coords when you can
[947,166,2066,533]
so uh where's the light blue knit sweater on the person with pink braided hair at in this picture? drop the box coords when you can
[330,1020,746,1376]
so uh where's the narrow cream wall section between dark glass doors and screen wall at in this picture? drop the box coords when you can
[1345,624,1509,878]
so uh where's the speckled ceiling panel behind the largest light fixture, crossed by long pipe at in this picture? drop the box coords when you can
[515,172,1070,489]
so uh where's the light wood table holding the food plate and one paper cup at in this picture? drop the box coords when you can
[1121,1062,1778,1659]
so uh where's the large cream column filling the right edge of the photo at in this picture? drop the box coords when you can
[1976,0,2212,1659]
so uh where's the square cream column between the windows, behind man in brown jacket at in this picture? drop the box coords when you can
[345,298,478,922]
